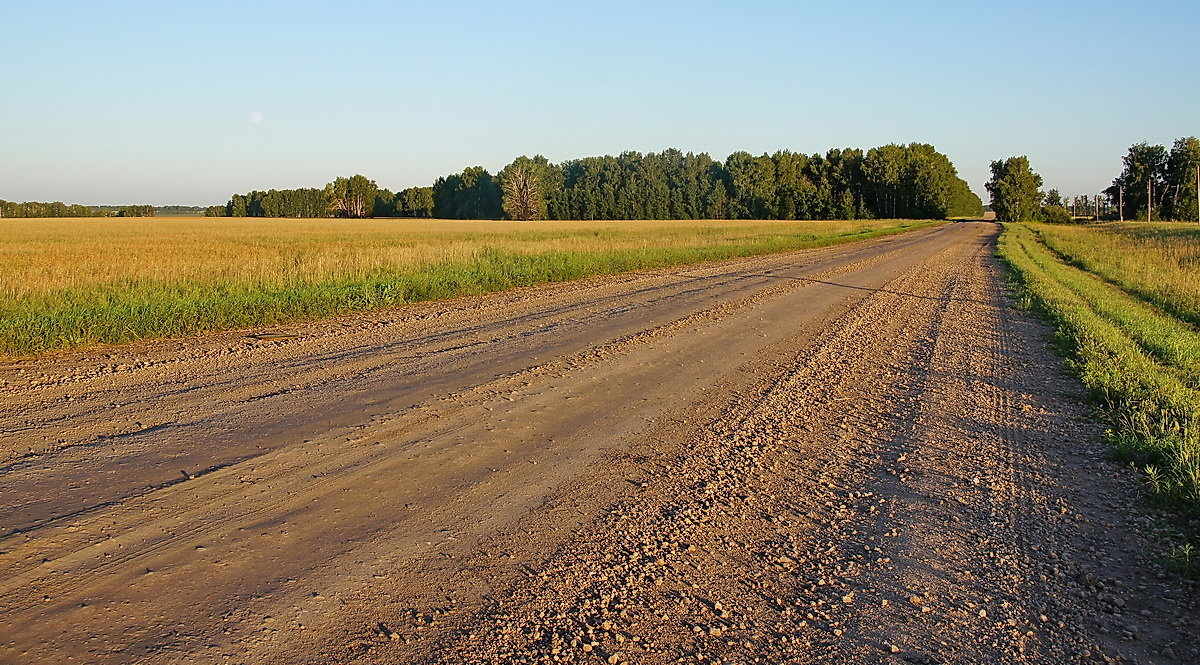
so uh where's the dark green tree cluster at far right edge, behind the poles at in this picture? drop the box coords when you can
[1104,137,1200,222]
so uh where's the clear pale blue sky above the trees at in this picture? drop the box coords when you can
[0,0,1200,204]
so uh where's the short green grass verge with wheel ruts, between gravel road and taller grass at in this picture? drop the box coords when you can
[1000,223,1200,576]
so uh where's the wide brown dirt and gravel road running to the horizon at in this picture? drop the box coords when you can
[0,223,1200,664]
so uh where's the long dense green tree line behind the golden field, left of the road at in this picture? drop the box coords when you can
[205,143,983,220]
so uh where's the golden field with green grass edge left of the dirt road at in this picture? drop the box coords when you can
[0,218,937,357]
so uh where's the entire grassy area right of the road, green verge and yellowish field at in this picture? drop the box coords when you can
[1000,223,1200,576]
